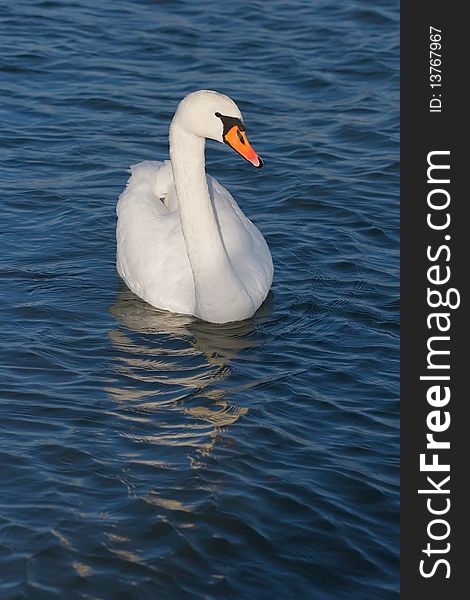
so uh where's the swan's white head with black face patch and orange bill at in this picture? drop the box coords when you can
[171,90,263,169]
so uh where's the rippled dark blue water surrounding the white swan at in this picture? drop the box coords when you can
[0,0,399,600]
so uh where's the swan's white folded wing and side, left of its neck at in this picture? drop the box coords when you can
[116,161,195,314]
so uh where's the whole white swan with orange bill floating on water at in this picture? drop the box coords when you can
[116,90,273,323]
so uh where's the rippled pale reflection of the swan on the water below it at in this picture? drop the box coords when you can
[107,285,270,451]
